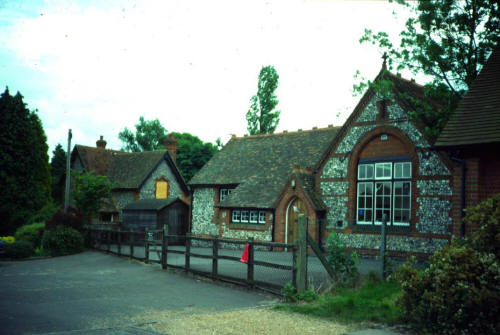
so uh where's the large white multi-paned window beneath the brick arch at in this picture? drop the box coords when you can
[356,161,412,226]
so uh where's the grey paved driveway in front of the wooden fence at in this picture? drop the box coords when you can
[0,251,275,334]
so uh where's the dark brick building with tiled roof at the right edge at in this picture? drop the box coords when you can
[435,46,500,236]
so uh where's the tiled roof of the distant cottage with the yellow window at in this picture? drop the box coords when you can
[72,144,189,194]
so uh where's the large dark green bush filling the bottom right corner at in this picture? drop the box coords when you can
[393,196,500,334]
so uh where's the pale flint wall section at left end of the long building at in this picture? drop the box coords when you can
[191,187,219,235]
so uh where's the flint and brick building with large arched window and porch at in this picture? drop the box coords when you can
[190,60,460,254]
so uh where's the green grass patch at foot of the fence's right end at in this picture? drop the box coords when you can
[276,281,401,324]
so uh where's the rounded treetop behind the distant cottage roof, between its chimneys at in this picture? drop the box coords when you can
[118,116,167,152]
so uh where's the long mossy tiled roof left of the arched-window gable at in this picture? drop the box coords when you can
[189,127,339,208]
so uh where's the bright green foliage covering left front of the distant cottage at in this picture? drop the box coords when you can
[72,171,111,221]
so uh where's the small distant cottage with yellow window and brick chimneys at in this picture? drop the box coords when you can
[71,136,190,222]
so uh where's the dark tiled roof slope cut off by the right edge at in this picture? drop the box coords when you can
[435,44,500,147]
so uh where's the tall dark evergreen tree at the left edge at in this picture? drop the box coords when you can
[0,88,51,235]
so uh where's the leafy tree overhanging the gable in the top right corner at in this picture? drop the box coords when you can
[355,0,500,138]
